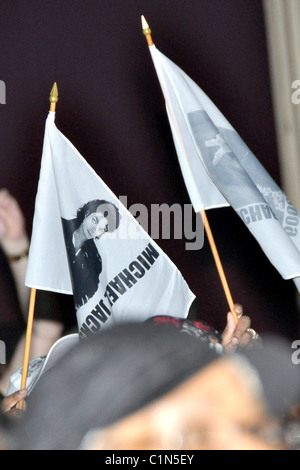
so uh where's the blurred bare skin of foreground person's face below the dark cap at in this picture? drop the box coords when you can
[81,358,283,451]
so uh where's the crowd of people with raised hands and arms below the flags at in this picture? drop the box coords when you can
[0,190,300,451]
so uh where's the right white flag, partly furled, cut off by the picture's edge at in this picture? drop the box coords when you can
[149,46,300,291]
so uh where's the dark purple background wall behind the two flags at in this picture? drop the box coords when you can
[0,0,297,354]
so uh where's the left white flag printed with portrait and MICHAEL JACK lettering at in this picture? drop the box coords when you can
[26,112,195,337]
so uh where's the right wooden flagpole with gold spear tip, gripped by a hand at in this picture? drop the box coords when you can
[142,15,238,323]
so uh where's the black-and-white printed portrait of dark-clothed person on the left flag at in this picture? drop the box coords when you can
[62,199,121,310]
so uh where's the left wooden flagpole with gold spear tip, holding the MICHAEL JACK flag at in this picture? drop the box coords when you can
[17,82,58,410]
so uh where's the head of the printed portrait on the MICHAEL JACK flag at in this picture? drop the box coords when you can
[76,199,120,240]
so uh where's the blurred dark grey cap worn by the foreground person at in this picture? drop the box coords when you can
[12,323,220,450]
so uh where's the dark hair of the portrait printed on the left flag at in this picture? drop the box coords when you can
[74,199,121,232]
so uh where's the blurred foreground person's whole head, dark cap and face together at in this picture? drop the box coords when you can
[9,323,300,450]
